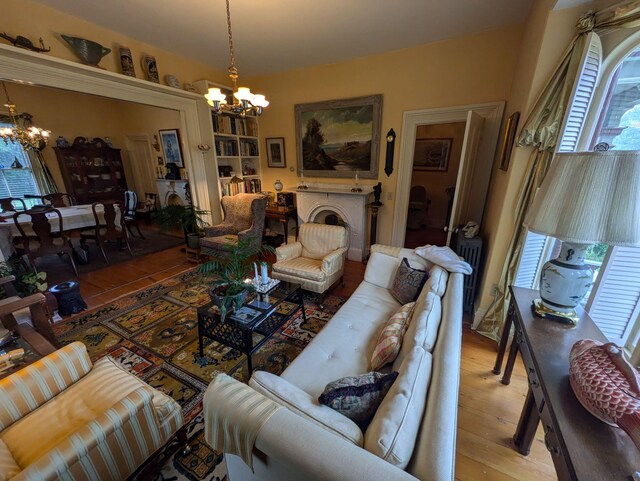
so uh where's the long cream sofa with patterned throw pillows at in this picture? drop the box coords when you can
[205,245,462,481]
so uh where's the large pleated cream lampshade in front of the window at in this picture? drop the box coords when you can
[524,150,640,247]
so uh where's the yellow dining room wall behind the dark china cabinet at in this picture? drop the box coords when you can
[7,82,180,196]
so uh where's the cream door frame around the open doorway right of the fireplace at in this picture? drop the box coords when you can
[391,101,505,247]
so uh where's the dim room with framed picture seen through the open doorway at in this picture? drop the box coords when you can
[404,122,466,249]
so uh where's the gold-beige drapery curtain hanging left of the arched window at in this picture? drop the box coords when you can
[475,1,640,340]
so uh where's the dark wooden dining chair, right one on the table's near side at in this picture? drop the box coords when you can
[80,200,133,264]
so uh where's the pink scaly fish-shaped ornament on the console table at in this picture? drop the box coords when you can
[569,339,640,449]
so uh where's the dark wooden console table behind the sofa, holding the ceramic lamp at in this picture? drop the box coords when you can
[494,287,640,481]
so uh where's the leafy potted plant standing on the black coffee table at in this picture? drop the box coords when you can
[198,237,275,322]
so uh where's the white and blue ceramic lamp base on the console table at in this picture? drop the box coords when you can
[534,242,593,324]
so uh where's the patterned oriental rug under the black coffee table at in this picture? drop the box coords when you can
[55,270,344,481]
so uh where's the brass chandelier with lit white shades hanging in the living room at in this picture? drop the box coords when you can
[204,0,269,116]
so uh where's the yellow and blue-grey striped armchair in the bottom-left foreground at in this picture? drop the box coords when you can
[0,342,186,481]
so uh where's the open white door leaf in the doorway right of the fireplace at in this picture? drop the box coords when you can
[444,110,484,245]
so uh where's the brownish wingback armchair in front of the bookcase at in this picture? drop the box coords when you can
[200,194,267,254]
